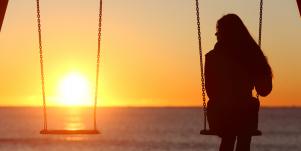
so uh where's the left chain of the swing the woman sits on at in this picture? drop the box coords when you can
[195,0,207,130]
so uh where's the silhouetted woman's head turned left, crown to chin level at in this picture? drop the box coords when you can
[216,14,255,44]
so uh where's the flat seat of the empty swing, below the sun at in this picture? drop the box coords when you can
[40,129,100,135]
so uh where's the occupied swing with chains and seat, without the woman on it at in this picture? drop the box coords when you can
[195,0,263,136]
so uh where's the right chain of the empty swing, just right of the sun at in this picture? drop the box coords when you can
[94,0,102,130]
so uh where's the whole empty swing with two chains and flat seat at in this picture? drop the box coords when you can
[36,0,102,135]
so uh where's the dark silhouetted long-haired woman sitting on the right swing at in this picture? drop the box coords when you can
[205,14,272,151]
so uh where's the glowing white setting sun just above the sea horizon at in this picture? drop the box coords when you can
[58,73,92,106]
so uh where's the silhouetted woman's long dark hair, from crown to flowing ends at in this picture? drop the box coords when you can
[217,14,272,93]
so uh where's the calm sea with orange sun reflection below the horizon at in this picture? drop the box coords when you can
[0,108,301,151]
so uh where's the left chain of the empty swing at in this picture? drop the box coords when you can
[36,0,47,130]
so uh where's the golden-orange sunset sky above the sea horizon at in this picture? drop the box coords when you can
[0,0,301,106]
